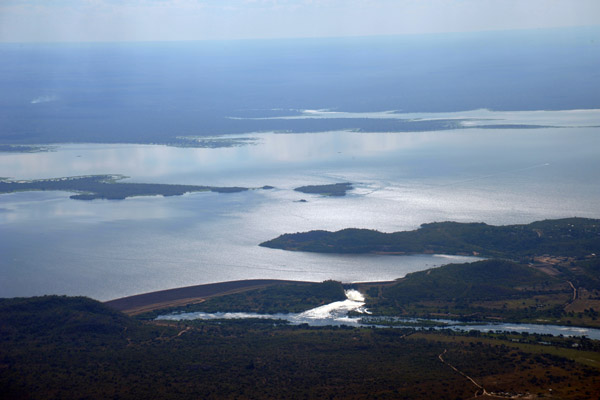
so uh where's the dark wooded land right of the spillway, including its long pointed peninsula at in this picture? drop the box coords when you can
[261,218,600,327]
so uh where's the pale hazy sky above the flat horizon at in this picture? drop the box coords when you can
[0,0,600,42]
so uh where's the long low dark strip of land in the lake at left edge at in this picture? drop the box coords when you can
[0,175,255,200]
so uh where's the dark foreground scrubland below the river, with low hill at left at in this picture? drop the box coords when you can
[0,296,600,399]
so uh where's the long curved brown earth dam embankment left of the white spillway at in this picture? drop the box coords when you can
[104,279,310,315]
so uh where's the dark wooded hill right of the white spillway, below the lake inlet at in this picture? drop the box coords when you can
[361,260,600,327]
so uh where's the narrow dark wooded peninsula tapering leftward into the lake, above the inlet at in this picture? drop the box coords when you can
[260,218,600,260]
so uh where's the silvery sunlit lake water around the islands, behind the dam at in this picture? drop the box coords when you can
[0,122,600,300]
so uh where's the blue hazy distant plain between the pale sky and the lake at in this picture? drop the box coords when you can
[0,27,600,144]
